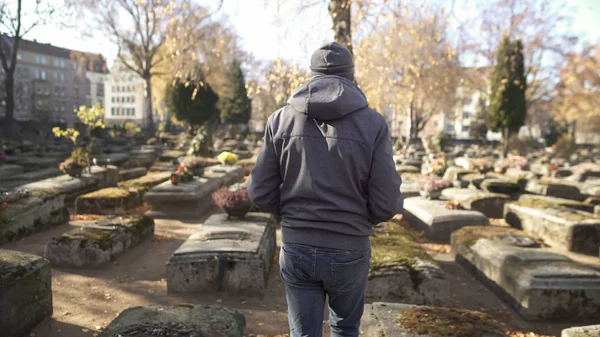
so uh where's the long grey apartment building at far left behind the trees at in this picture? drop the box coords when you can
[0,36,107,126]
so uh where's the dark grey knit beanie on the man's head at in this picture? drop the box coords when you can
[310,42,354,81]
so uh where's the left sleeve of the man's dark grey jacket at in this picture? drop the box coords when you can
[246,123,282,215]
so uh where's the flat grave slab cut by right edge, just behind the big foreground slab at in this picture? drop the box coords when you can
[504,202,600,255]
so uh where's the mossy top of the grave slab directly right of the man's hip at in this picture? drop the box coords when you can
[371,221,435,276]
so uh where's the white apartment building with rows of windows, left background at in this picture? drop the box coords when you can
[104,61,146,126]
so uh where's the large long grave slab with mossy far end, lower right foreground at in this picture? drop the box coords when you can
[452,226,600,321]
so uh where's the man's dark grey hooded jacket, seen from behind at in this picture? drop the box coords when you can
[247,75,402,250]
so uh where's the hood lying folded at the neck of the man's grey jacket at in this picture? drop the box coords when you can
[288,75,369,121]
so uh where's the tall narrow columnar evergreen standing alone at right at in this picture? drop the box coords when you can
[487,36,527,156]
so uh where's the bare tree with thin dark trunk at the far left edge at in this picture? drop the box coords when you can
[0,0,60,138]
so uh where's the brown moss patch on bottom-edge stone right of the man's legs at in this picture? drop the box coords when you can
[397,307,505,337]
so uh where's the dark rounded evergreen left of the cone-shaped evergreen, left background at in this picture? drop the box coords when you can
[165,74,219,135]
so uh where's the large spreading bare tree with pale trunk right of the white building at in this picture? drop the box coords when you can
[77,0,223,134]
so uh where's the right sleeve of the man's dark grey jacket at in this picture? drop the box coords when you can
[368,123,404,224]
